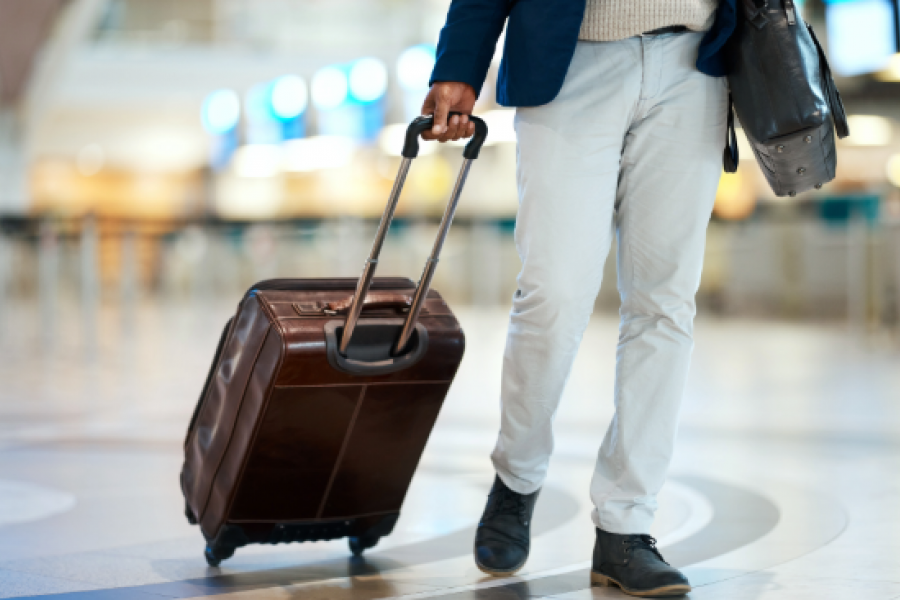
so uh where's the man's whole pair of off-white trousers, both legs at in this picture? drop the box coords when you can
[492,33,726,533]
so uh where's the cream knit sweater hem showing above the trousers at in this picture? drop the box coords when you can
[578,0,719,42]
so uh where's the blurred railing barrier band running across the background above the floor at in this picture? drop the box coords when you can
[0,213,900,342]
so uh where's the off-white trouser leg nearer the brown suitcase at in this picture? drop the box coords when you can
[492,40,641,494]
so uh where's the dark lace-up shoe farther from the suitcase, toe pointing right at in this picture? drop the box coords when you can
[591,529,691,596]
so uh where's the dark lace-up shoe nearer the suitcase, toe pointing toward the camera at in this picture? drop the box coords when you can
[475,477,540,576]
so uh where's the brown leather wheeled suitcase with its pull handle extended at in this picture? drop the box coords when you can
[181,117,487,566]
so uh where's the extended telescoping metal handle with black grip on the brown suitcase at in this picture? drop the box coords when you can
[339,113,487,356]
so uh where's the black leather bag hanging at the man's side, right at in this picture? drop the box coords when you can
[725,0,850,196]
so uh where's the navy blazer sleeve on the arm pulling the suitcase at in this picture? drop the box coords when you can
[429,0,513,93]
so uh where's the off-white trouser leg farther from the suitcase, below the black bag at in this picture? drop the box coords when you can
[591,33,726,534]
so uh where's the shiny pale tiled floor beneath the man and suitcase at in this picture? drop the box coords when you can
[0,301,900,600]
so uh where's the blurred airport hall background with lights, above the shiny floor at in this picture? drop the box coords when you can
[0,0,900,347]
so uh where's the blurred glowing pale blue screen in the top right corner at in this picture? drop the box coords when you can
[825,0,897,77]
